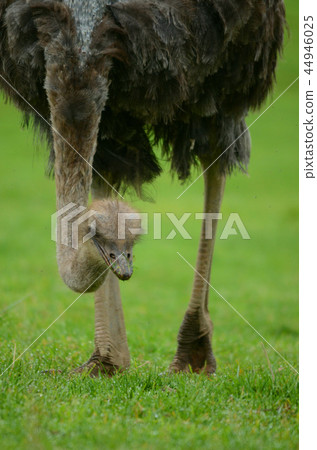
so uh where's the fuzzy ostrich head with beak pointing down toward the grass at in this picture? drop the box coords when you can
[88,200,140,280]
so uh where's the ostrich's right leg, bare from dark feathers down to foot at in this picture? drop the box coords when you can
[170,161,225,373]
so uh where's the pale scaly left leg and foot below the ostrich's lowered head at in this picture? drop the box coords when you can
[74,271,130,377]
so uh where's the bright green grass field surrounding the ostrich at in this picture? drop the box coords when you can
[0,0,298,450]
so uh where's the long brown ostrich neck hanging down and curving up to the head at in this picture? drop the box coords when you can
[45,0,110,292]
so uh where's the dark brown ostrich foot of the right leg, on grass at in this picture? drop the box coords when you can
[169,312,216,375]
